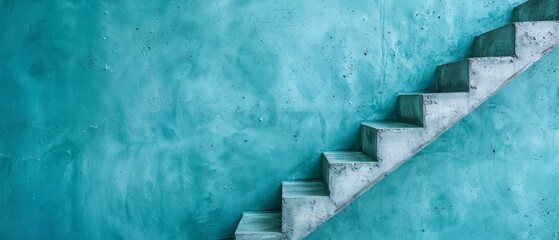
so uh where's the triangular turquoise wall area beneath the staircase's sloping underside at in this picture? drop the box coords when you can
[306,42,559,240]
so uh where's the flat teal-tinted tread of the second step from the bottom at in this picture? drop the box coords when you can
[282,181,328,198]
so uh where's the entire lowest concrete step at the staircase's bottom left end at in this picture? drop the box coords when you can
[235,212,285,240]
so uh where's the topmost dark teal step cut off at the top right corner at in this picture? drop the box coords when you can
[512,0,559,22]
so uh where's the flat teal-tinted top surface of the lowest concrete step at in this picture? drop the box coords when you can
[235,212,281,234]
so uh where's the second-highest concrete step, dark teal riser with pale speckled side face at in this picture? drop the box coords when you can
[471,21,559,59]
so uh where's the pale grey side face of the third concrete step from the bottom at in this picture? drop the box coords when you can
[323,158,380,208]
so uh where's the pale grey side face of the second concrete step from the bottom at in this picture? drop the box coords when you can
[282,197,336,239]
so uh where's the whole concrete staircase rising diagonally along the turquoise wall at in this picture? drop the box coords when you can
[235,0,559,239]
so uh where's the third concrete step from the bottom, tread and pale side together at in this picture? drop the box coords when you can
[322,151,380,208]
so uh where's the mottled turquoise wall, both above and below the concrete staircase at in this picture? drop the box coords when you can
[0,0,559,239]
